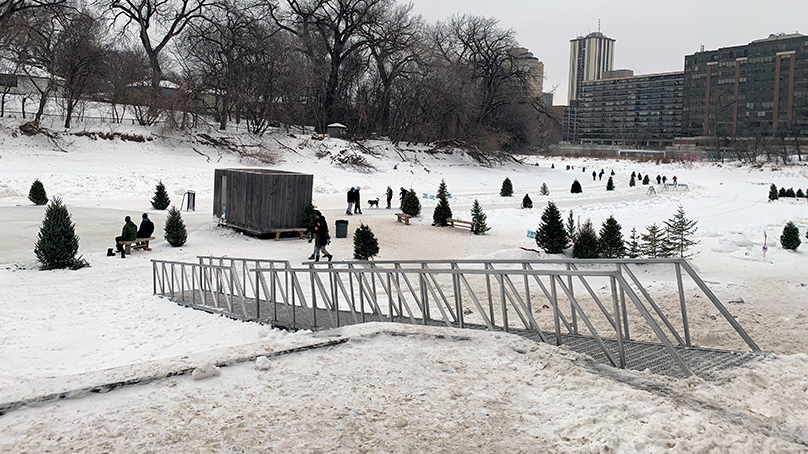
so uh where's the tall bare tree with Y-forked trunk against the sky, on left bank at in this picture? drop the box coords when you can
[110,0,209,121]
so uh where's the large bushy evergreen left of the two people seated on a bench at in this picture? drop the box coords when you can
[34,197,89,270]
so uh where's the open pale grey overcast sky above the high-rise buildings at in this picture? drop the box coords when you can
[410,0,808,105]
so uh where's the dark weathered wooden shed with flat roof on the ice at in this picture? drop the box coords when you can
[213,169,314,239]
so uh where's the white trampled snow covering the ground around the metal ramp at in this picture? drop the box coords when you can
[0,112,808,453]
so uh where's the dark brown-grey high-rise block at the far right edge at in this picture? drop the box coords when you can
[682,33,808,137]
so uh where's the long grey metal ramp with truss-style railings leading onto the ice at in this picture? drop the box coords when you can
[152,257,762,378]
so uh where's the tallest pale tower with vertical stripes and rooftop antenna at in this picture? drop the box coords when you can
[567,31,614,105]
